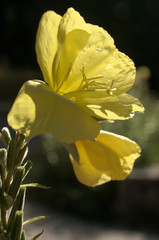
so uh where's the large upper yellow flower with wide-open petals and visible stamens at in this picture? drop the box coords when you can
[8,8,143,143]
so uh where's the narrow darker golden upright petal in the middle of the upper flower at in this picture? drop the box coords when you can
[54,29,90,94]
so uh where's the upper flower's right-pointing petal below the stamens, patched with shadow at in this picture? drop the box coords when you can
[65,90,144,120]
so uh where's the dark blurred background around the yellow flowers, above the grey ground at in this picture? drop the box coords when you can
[0,0,159,235]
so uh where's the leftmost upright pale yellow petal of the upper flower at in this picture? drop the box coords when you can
[35,11,61,88]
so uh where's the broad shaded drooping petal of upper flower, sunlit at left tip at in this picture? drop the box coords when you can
[8,81,101,143]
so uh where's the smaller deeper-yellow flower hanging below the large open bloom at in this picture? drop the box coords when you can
[70,131,141,187]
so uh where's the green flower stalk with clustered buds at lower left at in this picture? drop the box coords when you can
[0,128,44,240]
